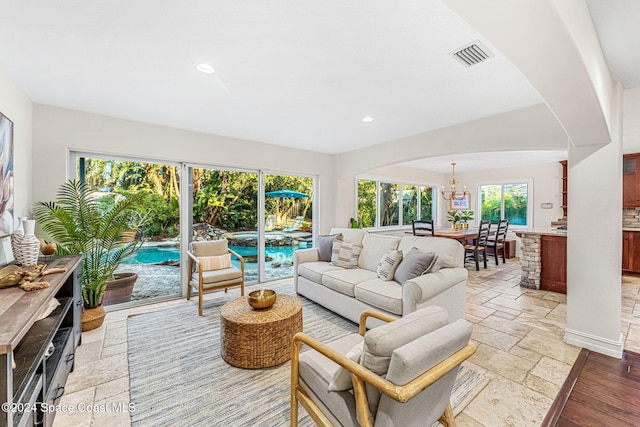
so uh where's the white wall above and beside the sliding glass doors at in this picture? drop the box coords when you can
[32,104,334,232]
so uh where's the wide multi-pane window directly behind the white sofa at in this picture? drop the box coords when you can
[357,179,435,228]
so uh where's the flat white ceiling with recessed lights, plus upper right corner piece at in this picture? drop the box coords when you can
[0,0,640,171]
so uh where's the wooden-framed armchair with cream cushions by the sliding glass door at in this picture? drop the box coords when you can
[187,239,244,316]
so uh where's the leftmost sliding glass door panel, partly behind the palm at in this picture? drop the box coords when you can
[71,153,182,301]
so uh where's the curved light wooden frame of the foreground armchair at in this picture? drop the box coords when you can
[291,310,476,427]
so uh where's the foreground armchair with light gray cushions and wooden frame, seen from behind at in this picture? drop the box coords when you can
[291,306,475,427]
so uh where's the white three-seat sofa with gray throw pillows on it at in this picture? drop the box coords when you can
[293,228,467,323]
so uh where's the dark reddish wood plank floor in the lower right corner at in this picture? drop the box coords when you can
[542,349,640,427]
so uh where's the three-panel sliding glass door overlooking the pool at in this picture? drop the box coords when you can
[69,153,315,301]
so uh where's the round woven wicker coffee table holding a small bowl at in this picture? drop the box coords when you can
[220,294,302,369]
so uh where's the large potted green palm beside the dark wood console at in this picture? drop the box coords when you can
[33,180,144,331]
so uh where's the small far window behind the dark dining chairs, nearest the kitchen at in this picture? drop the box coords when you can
[478,182,531,226]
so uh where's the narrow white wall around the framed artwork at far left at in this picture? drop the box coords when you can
[0,71,33,265]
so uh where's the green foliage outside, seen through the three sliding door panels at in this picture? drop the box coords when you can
[79,159,313,238]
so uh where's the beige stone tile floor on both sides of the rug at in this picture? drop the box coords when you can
[54,259,640,427]
